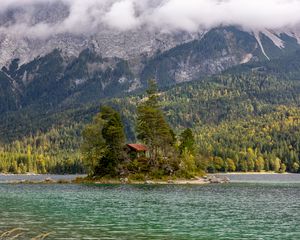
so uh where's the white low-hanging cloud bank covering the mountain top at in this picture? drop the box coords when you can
[0,0,300,37]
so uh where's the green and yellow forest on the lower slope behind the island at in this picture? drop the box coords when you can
[0,71,300,175]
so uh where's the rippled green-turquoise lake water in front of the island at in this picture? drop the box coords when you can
[0,174,300,240]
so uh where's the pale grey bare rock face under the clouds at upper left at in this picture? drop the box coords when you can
[0,1,203,66]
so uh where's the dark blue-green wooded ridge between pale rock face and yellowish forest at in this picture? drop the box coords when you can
[0,23,300,144]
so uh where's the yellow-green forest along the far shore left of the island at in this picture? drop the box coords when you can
[0,124,85,174]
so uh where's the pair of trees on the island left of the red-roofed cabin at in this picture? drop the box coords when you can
[82,106,125,177]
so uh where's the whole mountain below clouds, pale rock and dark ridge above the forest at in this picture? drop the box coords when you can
[0,1,300,144]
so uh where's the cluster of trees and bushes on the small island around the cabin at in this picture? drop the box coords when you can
[82,81,201,180]
